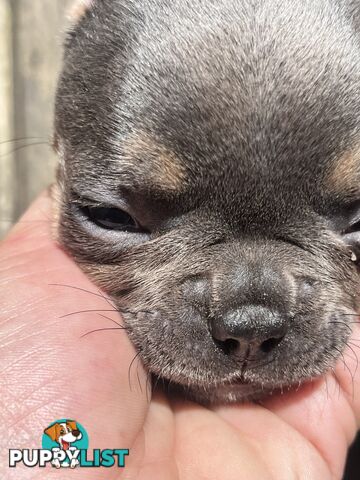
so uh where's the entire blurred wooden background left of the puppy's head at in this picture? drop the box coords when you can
[0,0,73,237]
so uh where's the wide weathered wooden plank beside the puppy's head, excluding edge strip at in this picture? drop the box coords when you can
[10,0,71,224]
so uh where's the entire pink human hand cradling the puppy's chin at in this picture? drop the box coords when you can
[0,189,360,480]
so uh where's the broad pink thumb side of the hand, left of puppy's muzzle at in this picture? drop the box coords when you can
[0,193,148,479]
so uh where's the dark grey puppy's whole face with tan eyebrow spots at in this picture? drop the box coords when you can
[55,0,360,401]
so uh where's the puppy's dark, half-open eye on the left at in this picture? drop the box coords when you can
[81,206,142,232]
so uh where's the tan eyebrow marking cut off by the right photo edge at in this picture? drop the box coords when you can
[326,147,360,194]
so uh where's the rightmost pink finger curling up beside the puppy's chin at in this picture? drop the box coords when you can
[211,325,360,478]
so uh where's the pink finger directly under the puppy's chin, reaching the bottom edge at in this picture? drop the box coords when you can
[174,398,331,480]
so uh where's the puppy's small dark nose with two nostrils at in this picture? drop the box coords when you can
[210,305,288,359]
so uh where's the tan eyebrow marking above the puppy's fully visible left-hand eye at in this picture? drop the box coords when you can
[122,132,185,191]
